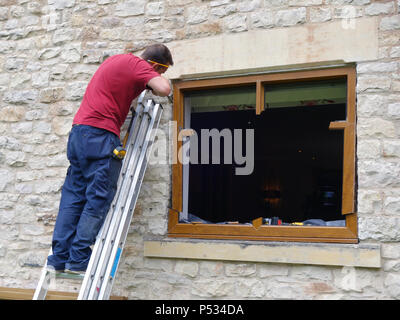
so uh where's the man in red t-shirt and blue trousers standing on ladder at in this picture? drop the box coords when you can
[47,44,173,273]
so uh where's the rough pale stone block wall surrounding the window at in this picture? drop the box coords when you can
[0,0,400,299]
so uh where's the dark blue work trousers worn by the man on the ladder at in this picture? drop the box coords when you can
[47,125,122,271]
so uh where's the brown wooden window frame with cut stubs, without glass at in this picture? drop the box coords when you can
[168,66,358,243]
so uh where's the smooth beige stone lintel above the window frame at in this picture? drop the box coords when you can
[166,17,378,79]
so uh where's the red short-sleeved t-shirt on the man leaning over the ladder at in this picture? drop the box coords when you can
[73,54,160,136]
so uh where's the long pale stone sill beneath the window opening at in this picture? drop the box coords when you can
[144,239,381,268]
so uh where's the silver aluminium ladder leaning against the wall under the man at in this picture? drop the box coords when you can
[33,91,163,300]
